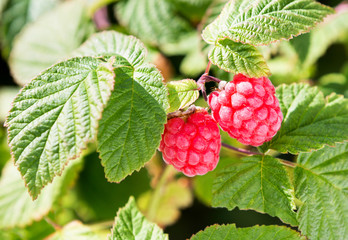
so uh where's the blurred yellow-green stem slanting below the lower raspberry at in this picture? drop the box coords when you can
[147,165,174,221]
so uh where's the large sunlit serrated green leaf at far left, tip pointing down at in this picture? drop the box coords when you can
[6,57,114,198]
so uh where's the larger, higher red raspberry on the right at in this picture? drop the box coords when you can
[208,74,283,146]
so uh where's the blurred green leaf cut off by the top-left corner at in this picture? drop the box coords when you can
[1,0,60,54]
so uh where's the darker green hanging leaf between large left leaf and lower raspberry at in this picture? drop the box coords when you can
[98,64,167,182]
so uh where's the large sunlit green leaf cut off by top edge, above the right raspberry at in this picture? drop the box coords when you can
[202,0,333,45]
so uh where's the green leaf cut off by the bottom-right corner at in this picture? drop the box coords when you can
[294,143,348,240]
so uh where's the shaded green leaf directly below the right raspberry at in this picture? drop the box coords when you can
[212,156,298,226]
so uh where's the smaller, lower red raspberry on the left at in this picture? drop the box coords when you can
[159,109,221,177]
